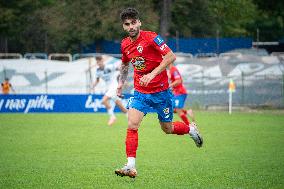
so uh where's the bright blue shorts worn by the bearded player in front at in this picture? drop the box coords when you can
[127,89,174,122]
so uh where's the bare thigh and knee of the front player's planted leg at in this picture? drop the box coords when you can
[128,108,145,129]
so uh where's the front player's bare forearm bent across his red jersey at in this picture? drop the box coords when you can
[140,51,176,86]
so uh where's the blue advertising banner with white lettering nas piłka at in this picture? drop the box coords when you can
[0,94,134,113]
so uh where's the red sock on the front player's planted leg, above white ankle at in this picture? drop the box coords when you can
[125,129,138,158]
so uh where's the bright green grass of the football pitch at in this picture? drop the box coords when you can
[0,111,284,189]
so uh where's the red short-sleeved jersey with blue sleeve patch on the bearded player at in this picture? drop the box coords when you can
[121,30,171,93]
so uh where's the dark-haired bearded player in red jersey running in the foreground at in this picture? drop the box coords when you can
[115,8,203,178]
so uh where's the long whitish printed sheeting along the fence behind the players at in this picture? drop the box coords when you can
[0,55,284,108]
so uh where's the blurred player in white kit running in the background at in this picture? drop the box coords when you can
[93,56,127,126]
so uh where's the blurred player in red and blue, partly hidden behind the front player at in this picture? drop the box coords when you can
[168,64,195,125]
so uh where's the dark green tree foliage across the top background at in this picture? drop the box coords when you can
[0,0,284,52]
